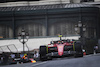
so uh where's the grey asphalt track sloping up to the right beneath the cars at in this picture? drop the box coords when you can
[0,54,100,67]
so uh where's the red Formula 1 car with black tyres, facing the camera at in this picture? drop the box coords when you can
[39,40,83,60]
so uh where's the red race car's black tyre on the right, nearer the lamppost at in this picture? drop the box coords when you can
[74,41,83,57]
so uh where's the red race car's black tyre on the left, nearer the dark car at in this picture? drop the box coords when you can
[39,46,47,61]
